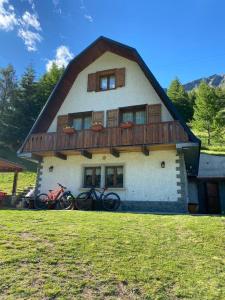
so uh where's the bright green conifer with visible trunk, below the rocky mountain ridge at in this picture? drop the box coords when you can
[193,81,218,145]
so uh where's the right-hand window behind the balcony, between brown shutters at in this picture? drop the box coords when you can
[121,108,146,124]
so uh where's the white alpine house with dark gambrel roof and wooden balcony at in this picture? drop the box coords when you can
[18,37,200,213]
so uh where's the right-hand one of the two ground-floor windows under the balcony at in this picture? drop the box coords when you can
[105,166,123,187]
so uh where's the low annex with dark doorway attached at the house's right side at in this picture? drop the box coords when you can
[189,153,225,214]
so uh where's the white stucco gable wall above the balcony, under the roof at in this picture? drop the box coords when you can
[48,52,172,132]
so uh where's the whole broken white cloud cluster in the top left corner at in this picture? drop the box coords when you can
[0,0,42,51]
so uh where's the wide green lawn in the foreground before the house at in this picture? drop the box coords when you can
[0,210,225,300]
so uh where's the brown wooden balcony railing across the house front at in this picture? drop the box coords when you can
[23,121,188,152]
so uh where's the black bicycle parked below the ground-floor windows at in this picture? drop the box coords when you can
[75,187,120,211]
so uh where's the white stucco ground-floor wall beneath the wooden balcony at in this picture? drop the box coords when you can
[40,150,179,201]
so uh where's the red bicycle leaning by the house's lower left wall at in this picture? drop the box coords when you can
[35,183,74,209]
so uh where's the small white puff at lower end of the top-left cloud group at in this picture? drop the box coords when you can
[18,28,42,51]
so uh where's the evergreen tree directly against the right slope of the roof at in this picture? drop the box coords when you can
[167,78,193,122]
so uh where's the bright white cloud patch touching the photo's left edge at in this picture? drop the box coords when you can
[0,0,18,31]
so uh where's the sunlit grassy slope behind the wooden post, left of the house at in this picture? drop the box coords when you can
[0,172,36,194]
